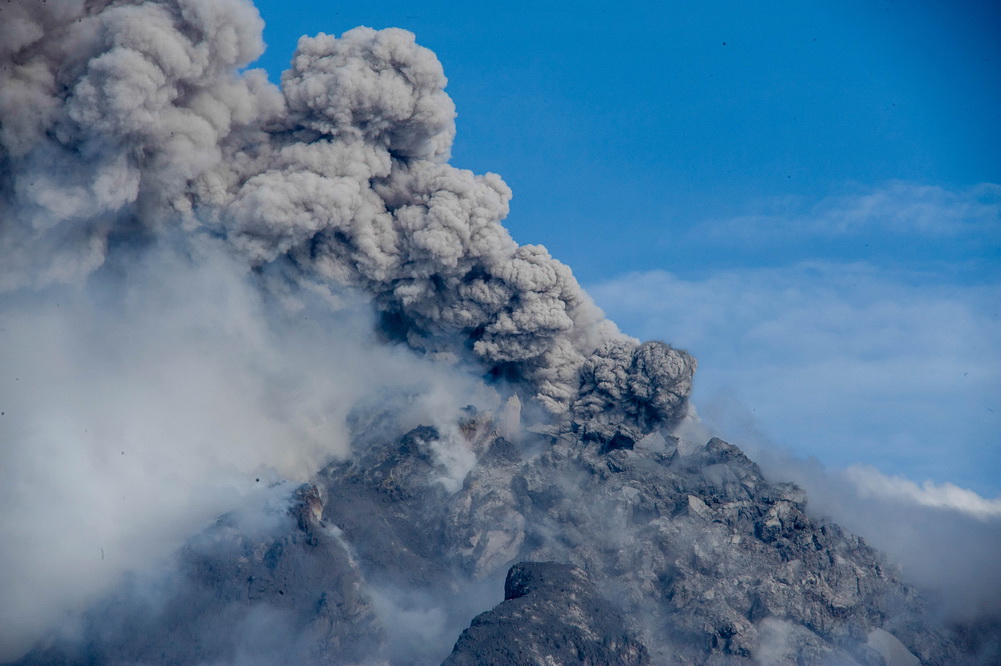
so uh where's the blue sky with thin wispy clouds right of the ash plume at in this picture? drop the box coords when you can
[246,0,1001,496]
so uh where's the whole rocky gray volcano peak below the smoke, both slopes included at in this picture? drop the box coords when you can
[15,413,990,666]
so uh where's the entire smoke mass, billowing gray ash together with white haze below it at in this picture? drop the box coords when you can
[0,0,695,661]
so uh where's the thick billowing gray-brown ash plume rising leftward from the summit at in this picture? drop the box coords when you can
[0,0,695,430]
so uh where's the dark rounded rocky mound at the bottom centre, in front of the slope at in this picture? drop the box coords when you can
[444,562,650,666]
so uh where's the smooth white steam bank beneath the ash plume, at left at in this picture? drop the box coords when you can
[0,240,497,661]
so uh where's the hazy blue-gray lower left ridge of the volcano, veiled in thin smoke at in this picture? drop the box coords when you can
[19,486,384,666]
